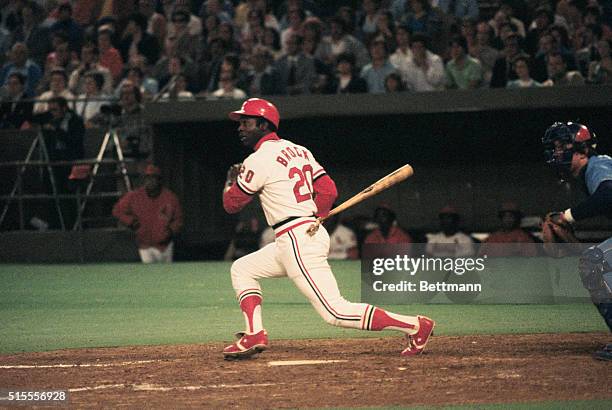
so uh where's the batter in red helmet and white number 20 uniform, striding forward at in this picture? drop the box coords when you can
[223,98,434,359]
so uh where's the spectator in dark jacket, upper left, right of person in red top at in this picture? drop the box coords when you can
[119,13,160,71]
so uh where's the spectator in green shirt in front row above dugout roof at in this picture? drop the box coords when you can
[446,37,483,90]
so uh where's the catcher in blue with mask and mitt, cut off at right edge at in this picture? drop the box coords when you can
[542,122,612,360]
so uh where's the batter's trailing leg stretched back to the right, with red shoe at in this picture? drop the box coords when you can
[277,225,434,354]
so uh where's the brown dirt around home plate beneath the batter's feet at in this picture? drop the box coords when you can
[0,333,612,408]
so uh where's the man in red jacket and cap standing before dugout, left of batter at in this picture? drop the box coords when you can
[113,164,183,263]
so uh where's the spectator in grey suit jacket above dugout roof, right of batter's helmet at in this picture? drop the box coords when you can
[275,35,317,95]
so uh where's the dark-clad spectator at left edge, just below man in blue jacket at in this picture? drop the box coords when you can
[0,72,33,129]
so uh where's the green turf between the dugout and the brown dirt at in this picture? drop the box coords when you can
[0,262,606,353]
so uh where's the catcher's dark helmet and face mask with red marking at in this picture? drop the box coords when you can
[542,122,597,170]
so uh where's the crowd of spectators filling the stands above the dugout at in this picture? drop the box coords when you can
[0,0,612,128]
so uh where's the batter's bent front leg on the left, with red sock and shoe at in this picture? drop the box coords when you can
[223,243,286,358]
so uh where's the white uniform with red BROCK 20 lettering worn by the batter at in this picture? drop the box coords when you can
[226,134,418,333]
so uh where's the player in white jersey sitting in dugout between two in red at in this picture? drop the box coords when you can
[425,205,475,257]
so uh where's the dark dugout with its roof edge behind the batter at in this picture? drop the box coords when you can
[0,86,612,262]
